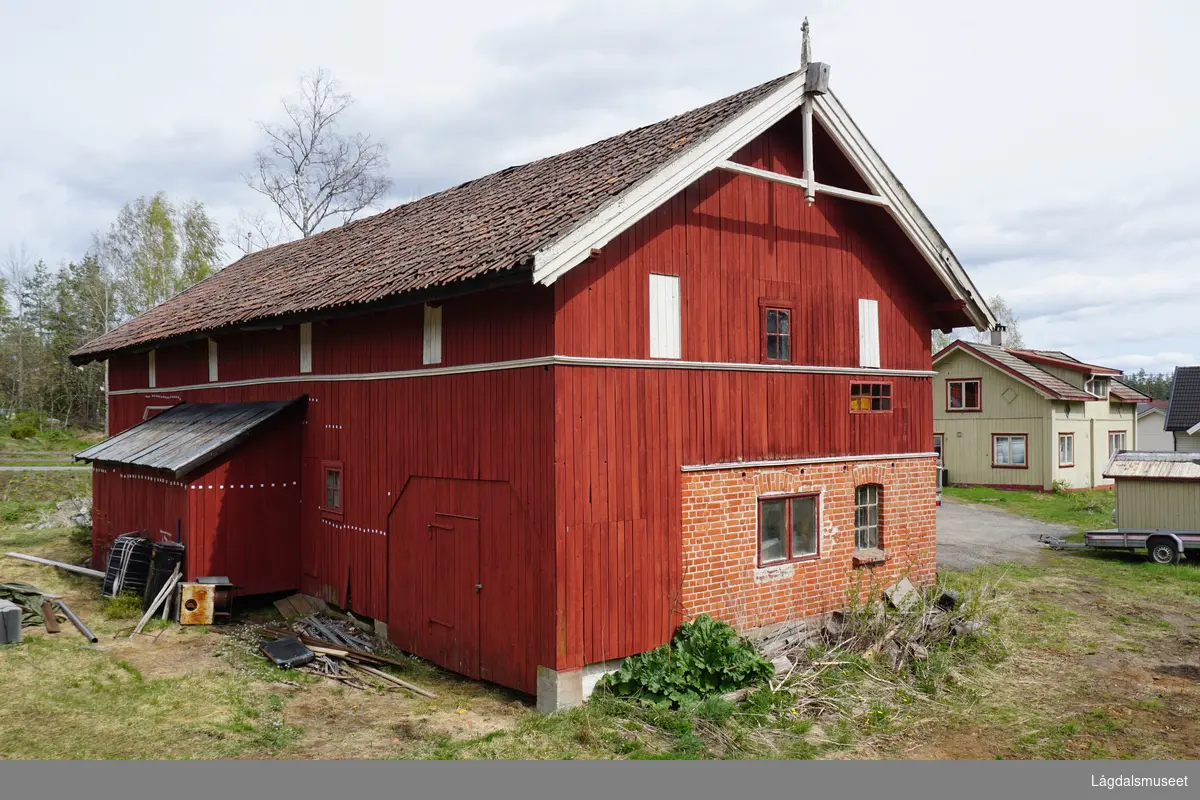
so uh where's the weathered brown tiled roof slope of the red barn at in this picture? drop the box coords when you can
[71,76,791,363]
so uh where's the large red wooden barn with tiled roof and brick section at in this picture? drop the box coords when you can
[72,56,994,708]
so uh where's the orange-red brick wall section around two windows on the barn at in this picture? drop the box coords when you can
[680,458,937,628]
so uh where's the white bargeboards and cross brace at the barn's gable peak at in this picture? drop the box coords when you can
[533,64,996,330]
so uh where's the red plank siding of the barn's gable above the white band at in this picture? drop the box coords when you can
[554,115,931,369]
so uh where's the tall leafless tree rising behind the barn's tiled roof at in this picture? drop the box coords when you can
[238,70,391,239]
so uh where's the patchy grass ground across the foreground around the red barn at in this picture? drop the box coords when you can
[0,479,1200,759]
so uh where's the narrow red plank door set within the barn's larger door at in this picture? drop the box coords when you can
[424,513,480,678]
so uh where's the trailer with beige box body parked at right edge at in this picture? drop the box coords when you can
[1042,451,1200,564]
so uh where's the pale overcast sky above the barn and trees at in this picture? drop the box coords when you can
[0,0,1200,371]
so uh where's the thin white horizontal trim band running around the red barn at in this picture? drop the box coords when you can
[108,355,935,396]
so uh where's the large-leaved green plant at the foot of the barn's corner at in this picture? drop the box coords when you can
[598,614,774,706]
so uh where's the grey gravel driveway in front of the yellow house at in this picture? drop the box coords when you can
[937,499,1075,570]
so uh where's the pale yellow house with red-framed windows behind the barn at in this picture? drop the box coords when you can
[934,331,1150,491]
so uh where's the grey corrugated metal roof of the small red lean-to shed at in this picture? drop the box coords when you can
[76,398,304,477]
